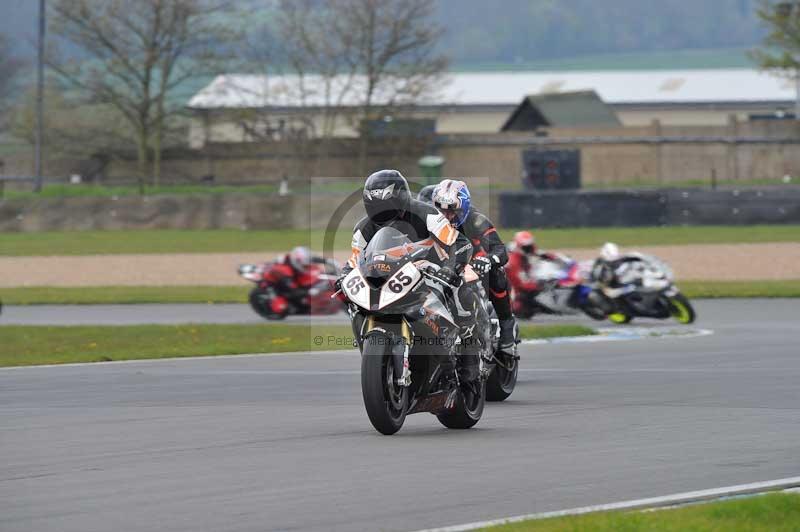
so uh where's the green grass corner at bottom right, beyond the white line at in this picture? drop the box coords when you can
[485,493,800,532]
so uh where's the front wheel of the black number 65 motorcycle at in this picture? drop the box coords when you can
[361,333,408,436]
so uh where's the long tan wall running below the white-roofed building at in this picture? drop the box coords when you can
[3,120,800,188]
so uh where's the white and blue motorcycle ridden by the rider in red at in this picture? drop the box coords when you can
[514,254,606,319]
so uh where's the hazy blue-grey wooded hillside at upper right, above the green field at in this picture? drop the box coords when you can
[438,0,763,67]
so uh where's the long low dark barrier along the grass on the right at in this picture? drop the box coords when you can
[498,187,800,227]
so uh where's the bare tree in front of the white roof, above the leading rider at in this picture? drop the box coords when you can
[260,0,447,173]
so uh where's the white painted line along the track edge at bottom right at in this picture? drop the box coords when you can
[417,477,800,532]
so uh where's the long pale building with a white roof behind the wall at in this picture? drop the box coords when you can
[188,69,795,147]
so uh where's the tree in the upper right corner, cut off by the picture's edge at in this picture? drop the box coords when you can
[751,0,800,120]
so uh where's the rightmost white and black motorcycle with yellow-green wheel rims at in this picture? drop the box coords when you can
[592,253,696,324]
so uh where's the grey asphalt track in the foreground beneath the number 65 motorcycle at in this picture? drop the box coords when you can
[0,300,800,532]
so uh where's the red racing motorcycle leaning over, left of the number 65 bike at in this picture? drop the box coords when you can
[234,259,343,320]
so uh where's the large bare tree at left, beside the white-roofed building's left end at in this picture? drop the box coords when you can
[48,0,238,191]
